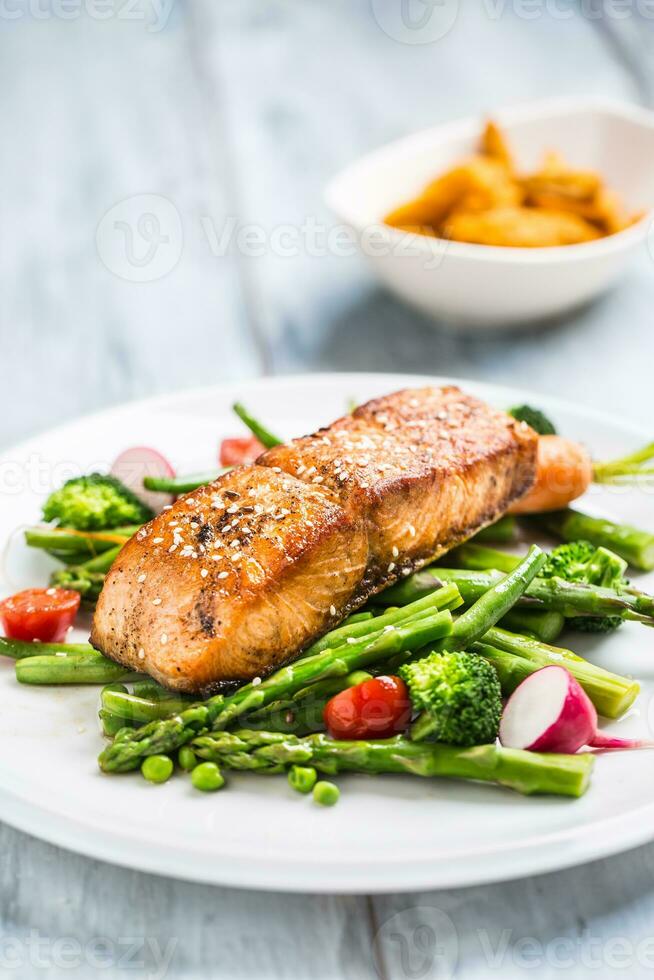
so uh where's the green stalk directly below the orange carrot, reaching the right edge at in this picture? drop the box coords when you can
[529,508,654,572]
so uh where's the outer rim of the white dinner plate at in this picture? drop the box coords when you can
[0,372,654,894]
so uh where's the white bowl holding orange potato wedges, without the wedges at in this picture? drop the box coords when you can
[325,99,654,328]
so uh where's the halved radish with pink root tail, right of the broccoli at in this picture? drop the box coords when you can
[500,664,652,754]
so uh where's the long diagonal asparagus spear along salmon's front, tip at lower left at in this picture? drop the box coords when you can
[99,590,452,772]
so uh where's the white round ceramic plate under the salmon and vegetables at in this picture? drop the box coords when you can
[0,374,654,892]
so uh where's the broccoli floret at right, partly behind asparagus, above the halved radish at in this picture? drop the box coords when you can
[540,541,629,633]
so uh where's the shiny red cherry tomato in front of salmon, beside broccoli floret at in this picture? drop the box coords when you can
[323,677,411,739]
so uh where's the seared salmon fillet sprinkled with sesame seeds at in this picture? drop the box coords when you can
[91,387,538,694]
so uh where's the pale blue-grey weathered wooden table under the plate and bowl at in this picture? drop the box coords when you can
[0,0,654,980]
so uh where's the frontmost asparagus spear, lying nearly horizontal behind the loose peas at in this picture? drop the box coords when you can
[192,730,594,797]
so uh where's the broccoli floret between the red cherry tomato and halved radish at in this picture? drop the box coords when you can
[399,652,502,746]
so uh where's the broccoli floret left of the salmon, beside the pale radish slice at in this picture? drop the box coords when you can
[43,473,154,531]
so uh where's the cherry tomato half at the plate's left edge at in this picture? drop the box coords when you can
[0,589,80,643]
